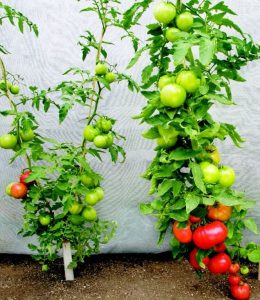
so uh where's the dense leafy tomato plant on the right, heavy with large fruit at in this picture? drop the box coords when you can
[128,0,260,296]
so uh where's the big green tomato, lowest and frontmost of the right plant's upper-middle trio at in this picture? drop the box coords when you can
[160,83,186,108]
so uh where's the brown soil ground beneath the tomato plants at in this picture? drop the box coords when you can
[0,253,260,300]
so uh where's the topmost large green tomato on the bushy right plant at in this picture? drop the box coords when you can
[153,2,176,24]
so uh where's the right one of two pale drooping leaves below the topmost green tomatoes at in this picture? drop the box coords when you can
[199,38,217,66]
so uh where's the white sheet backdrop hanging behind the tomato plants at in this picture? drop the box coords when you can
[0,0,260,253]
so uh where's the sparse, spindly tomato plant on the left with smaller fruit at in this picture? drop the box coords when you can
[0,0,140,270]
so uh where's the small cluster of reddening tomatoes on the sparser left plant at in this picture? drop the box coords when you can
[6,170,32,199]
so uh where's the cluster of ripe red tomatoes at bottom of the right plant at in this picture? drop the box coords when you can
[172,218,250,300]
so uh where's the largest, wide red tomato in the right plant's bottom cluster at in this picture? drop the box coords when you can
[193,221,228,250]
